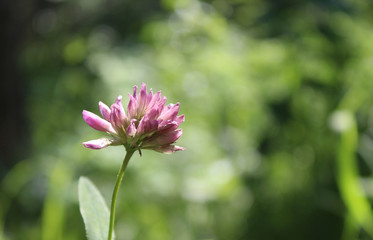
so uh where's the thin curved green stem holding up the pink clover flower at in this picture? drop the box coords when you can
[107,150,135,240]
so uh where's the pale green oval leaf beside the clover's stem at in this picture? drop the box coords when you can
[79,177,114,240]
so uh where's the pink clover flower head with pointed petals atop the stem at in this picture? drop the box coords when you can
[83,83,185,155]
